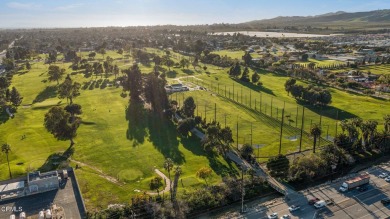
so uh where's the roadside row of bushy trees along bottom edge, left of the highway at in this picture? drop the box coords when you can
[86,174,272,219]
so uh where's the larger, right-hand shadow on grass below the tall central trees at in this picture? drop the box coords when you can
[148,112,185,165]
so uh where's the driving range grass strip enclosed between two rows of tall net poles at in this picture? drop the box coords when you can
[174,91,313,157]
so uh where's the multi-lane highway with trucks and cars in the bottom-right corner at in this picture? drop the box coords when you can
[215,163,390,219]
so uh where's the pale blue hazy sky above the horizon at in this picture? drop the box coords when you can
[0,0,390,28]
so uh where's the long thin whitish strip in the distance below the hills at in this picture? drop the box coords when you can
[215,31,340,38]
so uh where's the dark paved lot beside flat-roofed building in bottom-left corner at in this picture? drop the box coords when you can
[0,171,85,219]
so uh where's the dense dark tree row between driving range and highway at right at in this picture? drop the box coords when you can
[267,115,390,182]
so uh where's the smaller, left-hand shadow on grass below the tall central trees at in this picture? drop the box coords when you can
[125,101,148,147]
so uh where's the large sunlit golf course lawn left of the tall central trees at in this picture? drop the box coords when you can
[0,58,237,210]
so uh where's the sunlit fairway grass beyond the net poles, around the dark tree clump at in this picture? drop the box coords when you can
[178,65,390,141]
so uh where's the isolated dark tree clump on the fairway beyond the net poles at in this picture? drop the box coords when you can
[284,78,332,105]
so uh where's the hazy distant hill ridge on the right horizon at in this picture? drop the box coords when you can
[240,9,390,27]
